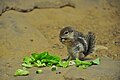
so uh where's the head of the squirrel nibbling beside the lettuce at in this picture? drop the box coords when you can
[59,27,75,44]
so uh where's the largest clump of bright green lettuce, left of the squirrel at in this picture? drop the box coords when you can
[22,52,61,67]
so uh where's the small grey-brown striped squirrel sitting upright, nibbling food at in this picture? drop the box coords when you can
[59,26,95,60]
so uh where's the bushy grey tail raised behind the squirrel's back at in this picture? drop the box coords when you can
[84,32,95,56]
